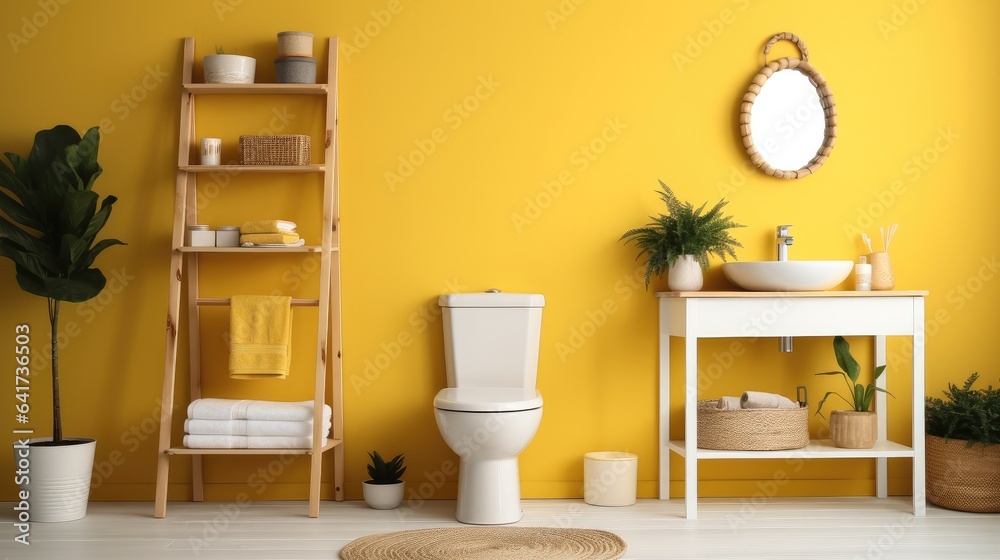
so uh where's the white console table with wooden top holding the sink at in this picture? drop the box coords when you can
[656,291,927,519]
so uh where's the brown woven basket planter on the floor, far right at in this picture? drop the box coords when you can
[926,436,1000,513]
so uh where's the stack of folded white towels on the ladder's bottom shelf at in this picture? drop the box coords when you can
[184,399,333,449]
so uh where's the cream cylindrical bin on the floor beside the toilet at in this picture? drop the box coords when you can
[583,451,639,506]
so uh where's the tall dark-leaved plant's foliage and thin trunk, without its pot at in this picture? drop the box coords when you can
[0,125,125,445]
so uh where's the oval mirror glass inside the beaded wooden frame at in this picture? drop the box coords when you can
[750,68,826,171]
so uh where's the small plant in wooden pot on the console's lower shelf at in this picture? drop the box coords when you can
[816,336,891,449]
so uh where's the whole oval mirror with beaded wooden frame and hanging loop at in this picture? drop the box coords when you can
[740,32,837,179]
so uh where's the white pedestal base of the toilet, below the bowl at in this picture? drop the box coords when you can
[455,457,523,525]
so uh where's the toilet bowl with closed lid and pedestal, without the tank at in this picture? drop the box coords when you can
[434,387,542,525]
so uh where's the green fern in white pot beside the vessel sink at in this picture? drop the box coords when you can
[619,181,746,291]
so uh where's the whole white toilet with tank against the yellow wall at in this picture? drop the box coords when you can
[434,290,545,525]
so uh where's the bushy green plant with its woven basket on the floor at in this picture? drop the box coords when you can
[924,373,1000,513]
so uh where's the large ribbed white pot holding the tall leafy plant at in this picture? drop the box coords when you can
[14,438,97,522]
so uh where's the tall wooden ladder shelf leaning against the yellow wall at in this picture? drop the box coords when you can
[154,37,344,518]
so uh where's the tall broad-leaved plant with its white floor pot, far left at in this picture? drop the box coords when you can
[0,125,124,521]
